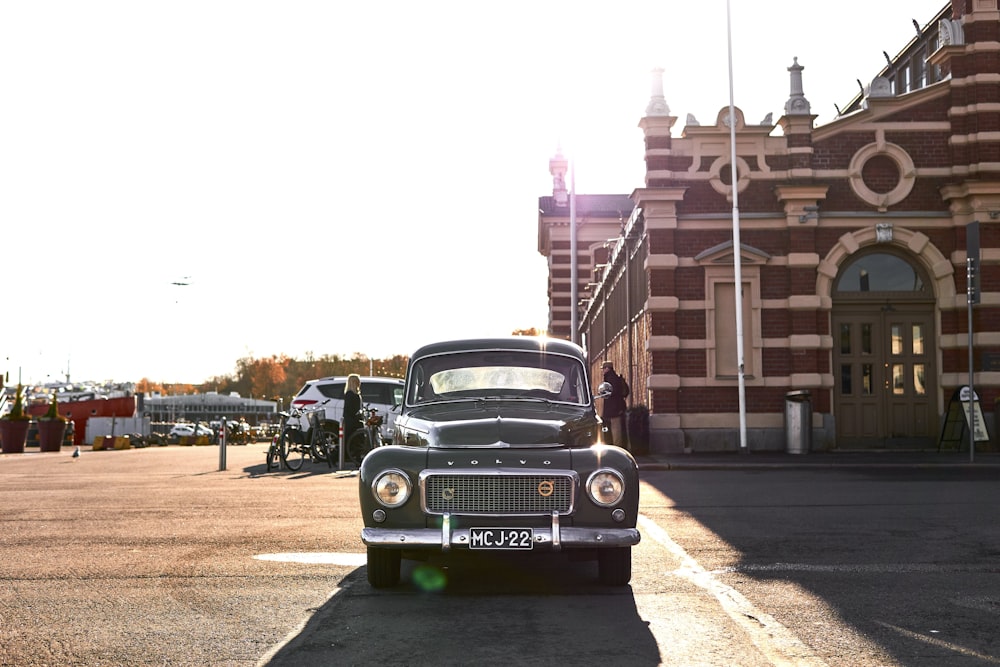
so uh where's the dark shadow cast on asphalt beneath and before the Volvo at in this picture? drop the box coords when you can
[260,553,662,667]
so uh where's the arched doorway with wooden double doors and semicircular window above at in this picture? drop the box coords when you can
[832,247,939,449]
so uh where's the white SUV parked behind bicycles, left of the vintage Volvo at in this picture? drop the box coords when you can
[292,376,403,436]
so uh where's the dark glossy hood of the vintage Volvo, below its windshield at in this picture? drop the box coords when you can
[403,401,597,448]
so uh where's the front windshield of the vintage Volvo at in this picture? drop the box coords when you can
[407,350,590,405]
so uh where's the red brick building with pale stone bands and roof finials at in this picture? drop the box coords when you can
[539,0,1000,451]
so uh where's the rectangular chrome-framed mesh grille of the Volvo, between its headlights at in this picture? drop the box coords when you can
[420,472,576,515]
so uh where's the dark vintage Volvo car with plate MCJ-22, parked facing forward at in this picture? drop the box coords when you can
[359,336,639,588]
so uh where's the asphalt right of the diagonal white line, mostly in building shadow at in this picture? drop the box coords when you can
[640,468,1000,665]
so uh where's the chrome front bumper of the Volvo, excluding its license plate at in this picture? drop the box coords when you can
[361,515,640,551]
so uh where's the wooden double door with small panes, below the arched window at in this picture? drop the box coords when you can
[832,303,939,449]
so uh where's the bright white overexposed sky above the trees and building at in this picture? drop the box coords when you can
[0,0,945,384]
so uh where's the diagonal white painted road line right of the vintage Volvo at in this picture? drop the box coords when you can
[639,515,826,667]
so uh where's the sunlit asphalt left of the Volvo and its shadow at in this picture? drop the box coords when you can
[0,445,363,666]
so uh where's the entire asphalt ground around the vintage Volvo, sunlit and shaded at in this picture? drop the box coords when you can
[0,444,1000,667]
